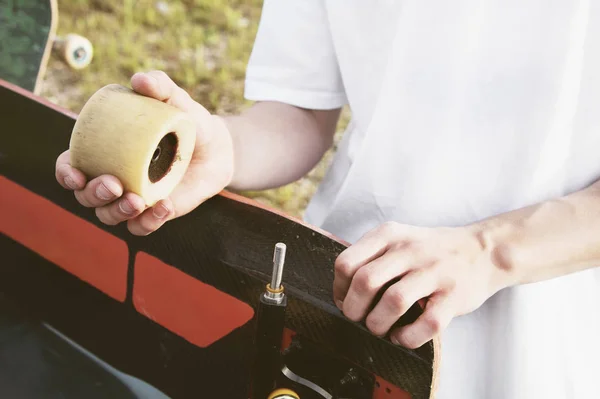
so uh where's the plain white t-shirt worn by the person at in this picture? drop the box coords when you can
[246,0,600,399]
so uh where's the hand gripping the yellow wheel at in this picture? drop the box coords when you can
[55,71,234,236]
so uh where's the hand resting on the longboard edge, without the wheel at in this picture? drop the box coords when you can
[333,222,509,349]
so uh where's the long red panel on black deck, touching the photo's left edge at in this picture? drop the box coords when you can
[0,176,128,302]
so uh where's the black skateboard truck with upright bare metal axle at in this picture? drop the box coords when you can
[250,243,373,399]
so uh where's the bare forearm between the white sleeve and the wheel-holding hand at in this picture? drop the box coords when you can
[223,102,340,190]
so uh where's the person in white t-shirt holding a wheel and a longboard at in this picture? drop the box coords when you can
[56,0,600,399]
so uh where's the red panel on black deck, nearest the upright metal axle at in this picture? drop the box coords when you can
[133,252,254,348]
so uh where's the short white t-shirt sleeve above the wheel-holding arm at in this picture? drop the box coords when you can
[244,0,346,109]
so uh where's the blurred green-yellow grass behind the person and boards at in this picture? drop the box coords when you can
[41,0,349,217]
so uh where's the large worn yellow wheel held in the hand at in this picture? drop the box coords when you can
[69,84,196,206]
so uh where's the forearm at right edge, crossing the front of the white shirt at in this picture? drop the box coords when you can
[471,182,600,285]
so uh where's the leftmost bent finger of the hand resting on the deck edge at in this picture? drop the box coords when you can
[333,230,388,309]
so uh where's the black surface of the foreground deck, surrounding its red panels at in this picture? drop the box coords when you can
[0,85,433,398]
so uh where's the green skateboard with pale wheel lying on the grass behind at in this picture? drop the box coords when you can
[0,0,93,94]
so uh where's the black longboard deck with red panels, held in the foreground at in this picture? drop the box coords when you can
[0,81,438,399]
